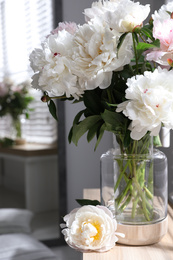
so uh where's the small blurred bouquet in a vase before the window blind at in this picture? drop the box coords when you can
[0,78,33,145]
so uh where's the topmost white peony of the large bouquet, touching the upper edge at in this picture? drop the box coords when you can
[84,0,150,33]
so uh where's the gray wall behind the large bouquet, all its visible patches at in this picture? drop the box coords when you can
[63,0,173,211]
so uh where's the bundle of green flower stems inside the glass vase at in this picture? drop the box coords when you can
[114,135,153,221]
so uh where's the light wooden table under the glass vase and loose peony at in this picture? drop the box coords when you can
[83,189,173,260]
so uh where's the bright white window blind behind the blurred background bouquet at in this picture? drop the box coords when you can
[0,0,57,143]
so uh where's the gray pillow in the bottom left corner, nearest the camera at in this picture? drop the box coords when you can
[0,234,57,260]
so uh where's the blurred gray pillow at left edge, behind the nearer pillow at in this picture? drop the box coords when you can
[0,208,33,234]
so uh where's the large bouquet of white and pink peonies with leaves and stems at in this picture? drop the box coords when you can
[30,0,173,248]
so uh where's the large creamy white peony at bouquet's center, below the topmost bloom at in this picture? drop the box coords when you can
[72,19,133,89]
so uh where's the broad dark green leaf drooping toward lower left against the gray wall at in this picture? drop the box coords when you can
[72,115,101,145]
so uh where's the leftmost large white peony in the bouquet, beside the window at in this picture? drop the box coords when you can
[30,30,83,98]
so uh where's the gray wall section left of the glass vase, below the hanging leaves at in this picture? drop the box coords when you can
[65,102,112,211]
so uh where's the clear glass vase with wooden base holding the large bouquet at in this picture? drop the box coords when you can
[101,135,168,245]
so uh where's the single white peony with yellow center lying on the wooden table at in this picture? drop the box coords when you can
[61,206,123,252]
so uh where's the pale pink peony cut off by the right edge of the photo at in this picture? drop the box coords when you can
[146,19,173,66]
